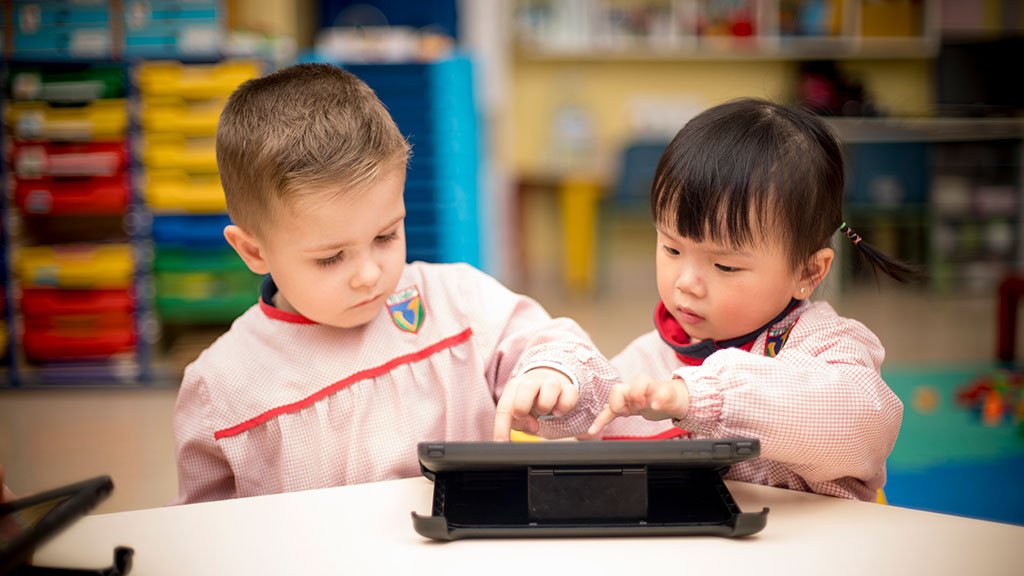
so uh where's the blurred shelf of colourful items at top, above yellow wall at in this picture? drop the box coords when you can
[516,0,939,61]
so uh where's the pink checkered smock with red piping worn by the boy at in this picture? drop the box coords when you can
[174,262,616,503]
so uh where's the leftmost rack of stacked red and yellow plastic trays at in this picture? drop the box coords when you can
[4,61,142,383]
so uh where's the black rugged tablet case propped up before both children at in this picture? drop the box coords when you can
[413,438,768,540]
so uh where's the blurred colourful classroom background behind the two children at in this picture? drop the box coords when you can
[0,0,1024,524]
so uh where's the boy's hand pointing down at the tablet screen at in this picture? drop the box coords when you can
[495,368,580,442]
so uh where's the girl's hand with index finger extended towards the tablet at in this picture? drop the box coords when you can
[587,374,690,436]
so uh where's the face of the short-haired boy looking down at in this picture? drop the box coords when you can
[249,166,406,328]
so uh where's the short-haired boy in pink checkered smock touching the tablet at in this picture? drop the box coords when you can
[174,64,616,503]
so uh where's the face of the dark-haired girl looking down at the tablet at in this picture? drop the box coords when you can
[655,225,811,340]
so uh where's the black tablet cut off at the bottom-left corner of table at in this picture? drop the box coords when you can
[0,476,114,574]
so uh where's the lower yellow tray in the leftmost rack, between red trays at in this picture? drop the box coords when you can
[14,244,134,288]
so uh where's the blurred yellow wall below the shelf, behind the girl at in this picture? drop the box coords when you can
[502,57,932,175]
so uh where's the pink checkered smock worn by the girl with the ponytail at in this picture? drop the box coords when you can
[602,302,903,500]
